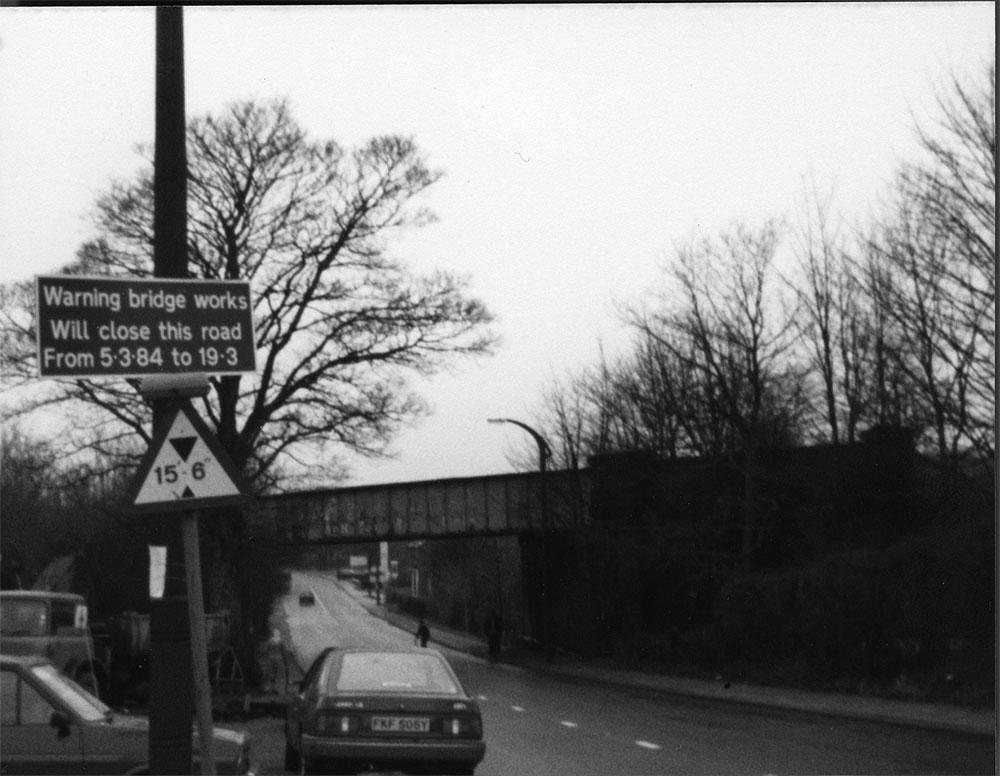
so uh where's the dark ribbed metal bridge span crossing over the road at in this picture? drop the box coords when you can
[248,469,591,545]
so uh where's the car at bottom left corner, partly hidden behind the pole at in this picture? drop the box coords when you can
[0,655,250,774]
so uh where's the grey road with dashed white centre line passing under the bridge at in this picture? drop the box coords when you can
[248,572,995,776]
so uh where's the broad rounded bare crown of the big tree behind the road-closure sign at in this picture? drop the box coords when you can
[3,97,494,484]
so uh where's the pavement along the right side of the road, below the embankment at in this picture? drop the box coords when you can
[331,577,997,738]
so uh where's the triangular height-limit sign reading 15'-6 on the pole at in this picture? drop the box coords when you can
[132,401,242,512]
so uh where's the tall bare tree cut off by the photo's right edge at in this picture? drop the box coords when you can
[869,64,996,460]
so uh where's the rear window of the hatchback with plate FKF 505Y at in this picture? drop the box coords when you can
[332,653,459,695]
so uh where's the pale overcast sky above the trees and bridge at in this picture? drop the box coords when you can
[0,2,996,484]
